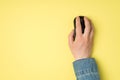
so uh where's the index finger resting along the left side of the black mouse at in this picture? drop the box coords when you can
[76,16,82,38]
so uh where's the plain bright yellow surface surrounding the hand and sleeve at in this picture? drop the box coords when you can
[0,0,120,80]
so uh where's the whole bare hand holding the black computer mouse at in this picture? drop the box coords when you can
[68,17,94,60]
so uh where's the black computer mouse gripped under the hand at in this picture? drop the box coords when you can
[73,16,85,40]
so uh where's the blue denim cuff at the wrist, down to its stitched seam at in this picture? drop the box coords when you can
[73,58,98,76]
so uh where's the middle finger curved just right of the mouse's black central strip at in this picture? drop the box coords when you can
[84,17,92,37]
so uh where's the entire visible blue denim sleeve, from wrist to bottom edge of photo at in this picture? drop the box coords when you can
[73,58,100,80]
